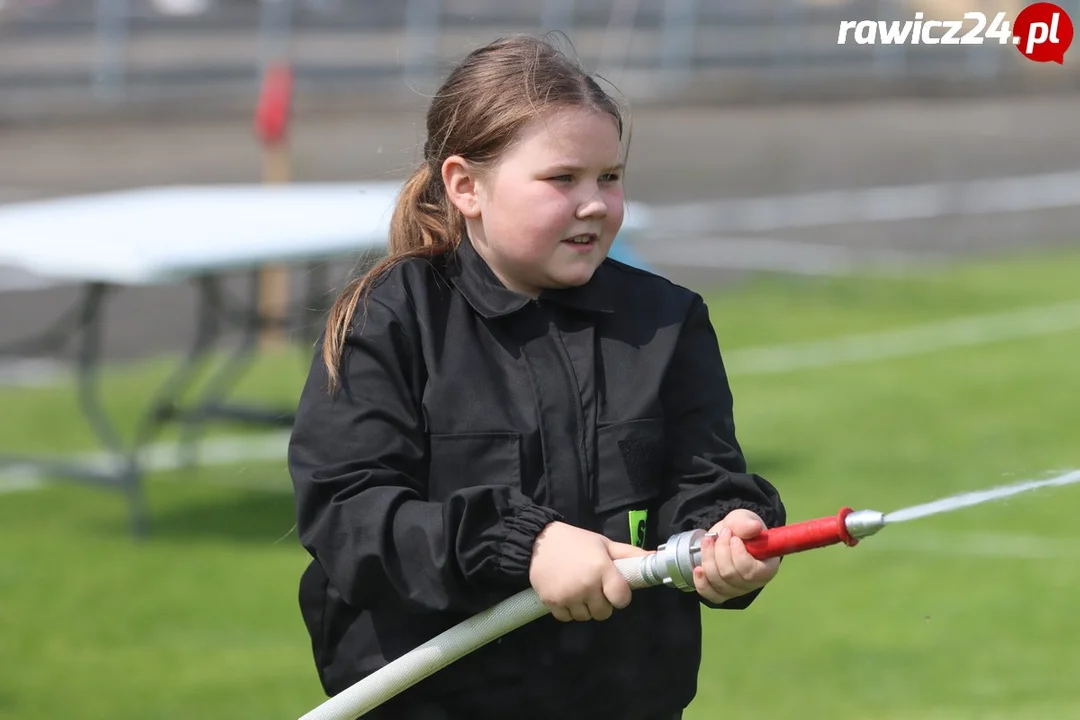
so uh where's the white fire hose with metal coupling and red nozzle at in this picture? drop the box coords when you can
[300,507,886,720]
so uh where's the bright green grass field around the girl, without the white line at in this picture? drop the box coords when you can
[0,245,1080,720]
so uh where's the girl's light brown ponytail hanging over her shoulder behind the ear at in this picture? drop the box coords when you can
[323,162,464,392]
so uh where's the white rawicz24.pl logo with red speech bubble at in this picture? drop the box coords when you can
[836,2,1072,65]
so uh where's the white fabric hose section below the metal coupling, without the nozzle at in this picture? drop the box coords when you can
[300,557,657,720]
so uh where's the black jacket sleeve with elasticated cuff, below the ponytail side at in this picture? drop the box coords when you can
[288,296,559,613]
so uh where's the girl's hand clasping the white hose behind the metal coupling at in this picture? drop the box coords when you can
[529,522,649,623]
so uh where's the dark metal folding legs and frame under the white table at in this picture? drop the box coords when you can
[0,262,327,536]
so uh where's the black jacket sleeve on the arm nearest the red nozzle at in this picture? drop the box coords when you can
[659,295,786,609]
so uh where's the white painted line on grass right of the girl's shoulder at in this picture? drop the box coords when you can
[725,302,1080,376]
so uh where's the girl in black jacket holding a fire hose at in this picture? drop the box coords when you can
[288,32,785,720]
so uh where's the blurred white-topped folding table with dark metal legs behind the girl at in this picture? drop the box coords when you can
[0,181,648,534]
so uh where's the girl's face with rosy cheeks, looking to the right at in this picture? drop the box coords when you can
[459,108,623,297]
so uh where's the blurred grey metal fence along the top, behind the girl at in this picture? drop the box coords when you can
[0,0,1080,120]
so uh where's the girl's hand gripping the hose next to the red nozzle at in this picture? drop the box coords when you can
[693,510,780,604]
